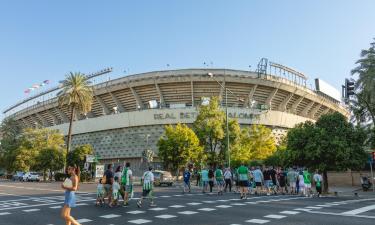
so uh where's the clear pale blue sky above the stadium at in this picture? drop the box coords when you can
[0,0,375,118]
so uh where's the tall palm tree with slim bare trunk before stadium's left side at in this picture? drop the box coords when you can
[59,72,94,156]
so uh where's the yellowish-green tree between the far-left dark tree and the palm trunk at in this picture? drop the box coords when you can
[13,128,64,171]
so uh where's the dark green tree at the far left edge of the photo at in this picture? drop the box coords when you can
[0,118,22,173]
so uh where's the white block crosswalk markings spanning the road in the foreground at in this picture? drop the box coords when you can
[0,194,375,225]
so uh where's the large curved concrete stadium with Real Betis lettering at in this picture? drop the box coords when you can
[4,58,349,172]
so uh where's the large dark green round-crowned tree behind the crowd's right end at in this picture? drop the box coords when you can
[286,113,366,192]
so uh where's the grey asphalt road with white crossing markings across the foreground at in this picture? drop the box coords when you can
[0,182,375,225]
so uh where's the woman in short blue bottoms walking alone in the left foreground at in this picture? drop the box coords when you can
[61,165,80,225]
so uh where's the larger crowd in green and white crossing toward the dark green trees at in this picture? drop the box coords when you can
[189,165,323,199]
